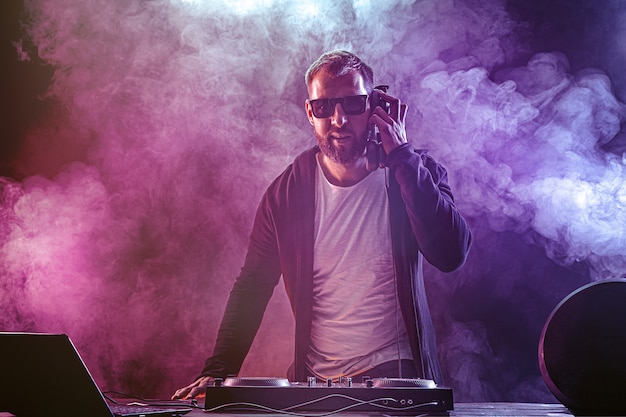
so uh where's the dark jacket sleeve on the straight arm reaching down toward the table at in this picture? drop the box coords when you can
[199,193,280,378]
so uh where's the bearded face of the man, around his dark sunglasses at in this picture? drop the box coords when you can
[306,70,370,165]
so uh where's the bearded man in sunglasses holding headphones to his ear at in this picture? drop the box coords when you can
[173,51,471,398]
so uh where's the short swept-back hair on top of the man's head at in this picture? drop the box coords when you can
[304,49,374,93]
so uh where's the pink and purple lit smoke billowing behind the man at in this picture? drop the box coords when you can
[0,0,626,401]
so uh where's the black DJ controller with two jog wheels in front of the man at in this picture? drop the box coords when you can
[204,377,454,416]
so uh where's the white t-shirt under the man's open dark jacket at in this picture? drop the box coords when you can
[307,154,412,379]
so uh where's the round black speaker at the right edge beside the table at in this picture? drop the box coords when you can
[539,279,626,415]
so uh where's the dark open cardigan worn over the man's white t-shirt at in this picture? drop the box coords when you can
[201,144,471,383]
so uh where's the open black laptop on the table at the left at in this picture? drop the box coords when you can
[0,332,191,417]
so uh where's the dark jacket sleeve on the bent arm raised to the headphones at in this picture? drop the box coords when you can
[387,144,472,272]
